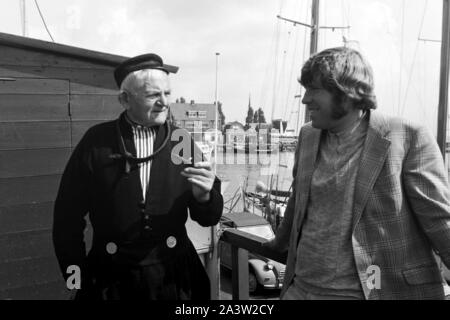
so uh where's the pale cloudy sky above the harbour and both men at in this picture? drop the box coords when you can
[0,0,442,134]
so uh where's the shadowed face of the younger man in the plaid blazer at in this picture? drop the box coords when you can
[302,77,348,131]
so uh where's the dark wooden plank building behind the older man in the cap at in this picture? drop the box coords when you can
[0,33,216,299]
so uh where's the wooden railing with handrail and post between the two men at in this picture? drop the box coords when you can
[220,228,286,300]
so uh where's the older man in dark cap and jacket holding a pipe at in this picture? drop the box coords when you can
[53,54,223,300]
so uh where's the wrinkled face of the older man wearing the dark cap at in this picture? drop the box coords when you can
[127,69,171,126]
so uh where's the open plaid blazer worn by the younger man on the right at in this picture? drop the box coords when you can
[269,112,450,299]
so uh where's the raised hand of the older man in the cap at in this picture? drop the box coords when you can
[181,161,215,202]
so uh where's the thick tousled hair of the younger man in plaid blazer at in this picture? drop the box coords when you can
[299,47,377,110]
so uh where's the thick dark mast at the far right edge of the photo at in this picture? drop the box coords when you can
[437,0,450,157]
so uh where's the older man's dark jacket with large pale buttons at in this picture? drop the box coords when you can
[53,115,223,296]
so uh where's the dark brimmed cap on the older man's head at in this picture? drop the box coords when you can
[114,53,169,88]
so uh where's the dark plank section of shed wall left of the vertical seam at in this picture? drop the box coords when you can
[0,78,71,299]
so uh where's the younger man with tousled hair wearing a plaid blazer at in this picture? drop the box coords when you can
[267,48,450,299]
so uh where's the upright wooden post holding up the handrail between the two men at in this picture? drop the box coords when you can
[231,245,249,300]
